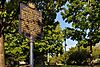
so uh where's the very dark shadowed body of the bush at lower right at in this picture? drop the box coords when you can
[67,50,90,64]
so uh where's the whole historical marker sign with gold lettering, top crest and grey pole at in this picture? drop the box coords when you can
[19,2,43,67]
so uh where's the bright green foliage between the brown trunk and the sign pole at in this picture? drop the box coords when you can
[4,20,29,64]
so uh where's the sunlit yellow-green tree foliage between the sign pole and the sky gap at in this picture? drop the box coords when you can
[34,24,63,62]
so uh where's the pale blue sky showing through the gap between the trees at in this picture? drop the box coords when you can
[55,12,77,50]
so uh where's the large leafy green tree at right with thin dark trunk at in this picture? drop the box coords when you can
[62,0,100,65]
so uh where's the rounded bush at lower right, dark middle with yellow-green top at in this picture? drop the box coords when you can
[65,47,90,65]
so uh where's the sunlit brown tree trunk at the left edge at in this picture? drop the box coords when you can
[0,34,5,67]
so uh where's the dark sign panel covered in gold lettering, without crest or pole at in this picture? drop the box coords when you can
[20,4,42,37]
